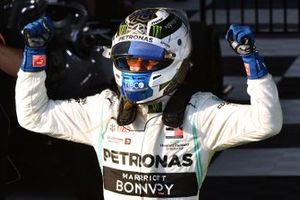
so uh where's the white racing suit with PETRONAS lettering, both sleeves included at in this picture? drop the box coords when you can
[16,70,282,200]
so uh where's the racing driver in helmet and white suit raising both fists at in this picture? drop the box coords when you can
[16,8,282,200]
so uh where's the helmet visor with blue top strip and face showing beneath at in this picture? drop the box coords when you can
[112,41,175,72]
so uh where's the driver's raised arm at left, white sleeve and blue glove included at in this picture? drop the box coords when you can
[16,18,109,144]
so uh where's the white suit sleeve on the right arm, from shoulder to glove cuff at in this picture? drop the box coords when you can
[192,74,283,151]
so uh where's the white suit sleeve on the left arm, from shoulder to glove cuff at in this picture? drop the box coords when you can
[16,70,116,144]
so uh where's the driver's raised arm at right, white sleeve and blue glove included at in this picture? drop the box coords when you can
[194,25,282,150]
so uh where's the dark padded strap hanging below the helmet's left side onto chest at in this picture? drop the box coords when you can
[117,98,137,126]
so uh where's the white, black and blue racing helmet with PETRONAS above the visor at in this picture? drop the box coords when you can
[111,8,191,104]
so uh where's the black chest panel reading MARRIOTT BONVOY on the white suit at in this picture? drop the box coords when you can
[103,167,199,198]
